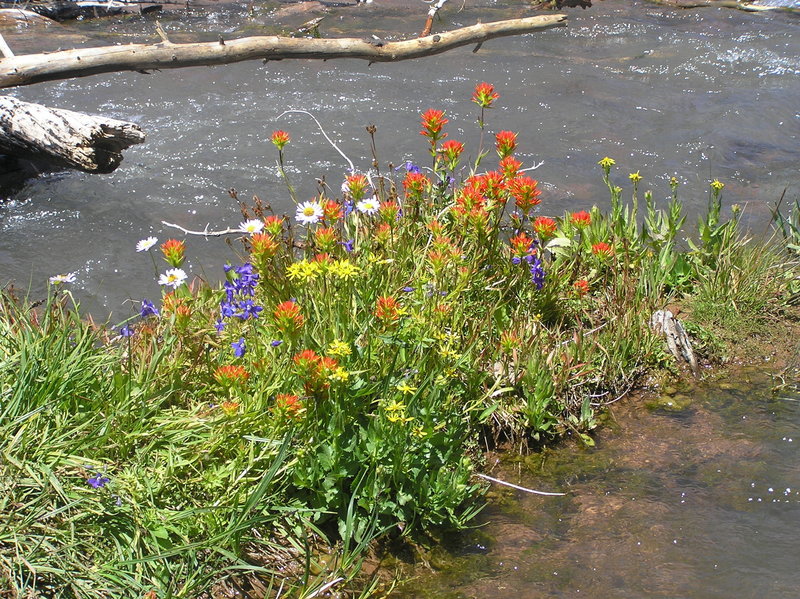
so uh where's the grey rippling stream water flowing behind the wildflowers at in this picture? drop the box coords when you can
[0,0,800,314]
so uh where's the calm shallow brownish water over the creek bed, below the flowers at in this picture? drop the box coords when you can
[394,369,800,599]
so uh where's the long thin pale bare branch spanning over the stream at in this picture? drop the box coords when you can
[0,14,567,88]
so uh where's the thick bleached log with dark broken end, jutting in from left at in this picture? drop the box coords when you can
[0,97,144,173]
